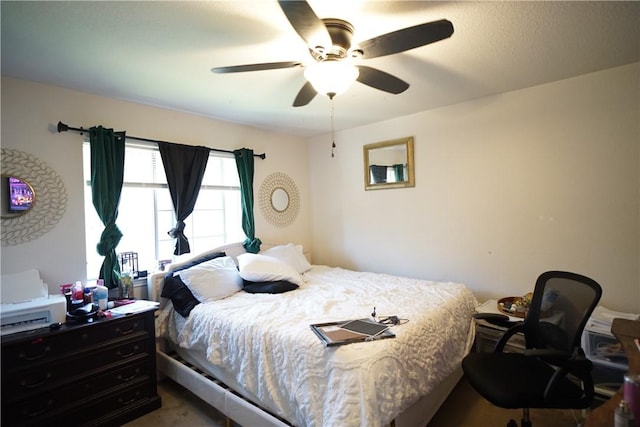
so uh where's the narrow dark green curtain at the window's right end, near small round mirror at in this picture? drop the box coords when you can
[233,148,262,254]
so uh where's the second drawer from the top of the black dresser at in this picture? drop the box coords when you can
[2,334,155,406]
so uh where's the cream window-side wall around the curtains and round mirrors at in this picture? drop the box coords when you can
[1,77,311,292]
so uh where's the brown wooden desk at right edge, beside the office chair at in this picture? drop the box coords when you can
[585,319,640,427]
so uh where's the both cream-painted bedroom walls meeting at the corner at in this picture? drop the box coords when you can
[1,64,640,312]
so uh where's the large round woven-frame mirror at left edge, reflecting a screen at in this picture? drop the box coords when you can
[0,148,67,246]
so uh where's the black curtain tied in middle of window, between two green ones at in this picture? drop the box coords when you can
[158,142,210,255]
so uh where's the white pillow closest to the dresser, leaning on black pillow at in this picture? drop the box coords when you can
[174,256,242,302]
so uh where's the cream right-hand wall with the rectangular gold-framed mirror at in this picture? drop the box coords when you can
[309,63,640,312]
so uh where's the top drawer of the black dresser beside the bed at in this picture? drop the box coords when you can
[2,316,153,371]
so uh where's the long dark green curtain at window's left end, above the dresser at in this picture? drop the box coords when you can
[89,126,125,288]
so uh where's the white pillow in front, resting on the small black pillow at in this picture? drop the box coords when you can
[238,253,302,285]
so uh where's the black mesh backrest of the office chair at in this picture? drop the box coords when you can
[523,271,602,352]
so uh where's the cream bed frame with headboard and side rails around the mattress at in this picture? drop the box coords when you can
[147,243,462,427]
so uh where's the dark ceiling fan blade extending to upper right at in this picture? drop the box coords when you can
[359,19,453,58]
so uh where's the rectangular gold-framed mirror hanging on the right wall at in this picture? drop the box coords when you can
[363,137,415,190]
